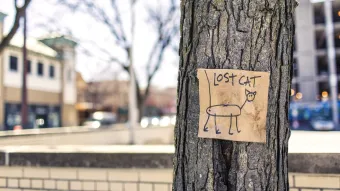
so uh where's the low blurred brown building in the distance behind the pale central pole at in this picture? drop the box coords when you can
[76,77,177,123]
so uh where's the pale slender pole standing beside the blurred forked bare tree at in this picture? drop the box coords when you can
[128,0,138,145]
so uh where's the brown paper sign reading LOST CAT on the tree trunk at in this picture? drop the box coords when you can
[197,69,269,142]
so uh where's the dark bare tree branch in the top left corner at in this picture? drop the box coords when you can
[0,0,32,53]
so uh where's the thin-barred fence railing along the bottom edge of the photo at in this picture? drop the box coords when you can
[0,177,340,191]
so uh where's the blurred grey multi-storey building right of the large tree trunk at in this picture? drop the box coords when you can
[292,0,340,102]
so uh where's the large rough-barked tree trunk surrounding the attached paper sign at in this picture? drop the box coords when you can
[173,0,296,191]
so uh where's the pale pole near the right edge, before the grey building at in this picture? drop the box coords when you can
[324,0,339,126]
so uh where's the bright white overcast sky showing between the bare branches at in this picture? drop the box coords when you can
[0,0,179,87]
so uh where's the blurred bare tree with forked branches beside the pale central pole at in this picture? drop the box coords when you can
[57,0,179,117]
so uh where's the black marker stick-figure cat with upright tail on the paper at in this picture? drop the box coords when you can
[203,70,256,135]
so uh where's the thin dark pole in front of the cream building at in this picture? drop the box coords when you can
[21,10,28,128]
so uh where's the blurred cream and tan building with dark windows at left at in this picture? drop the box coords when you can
[0,13,77,129]
